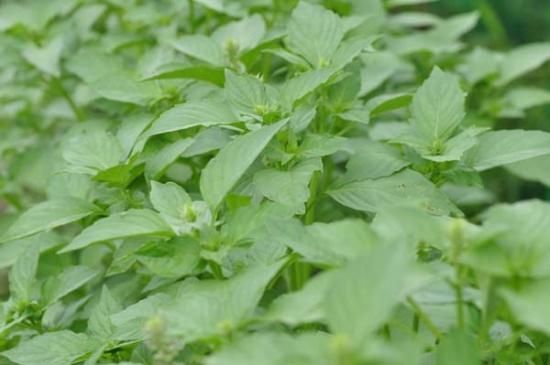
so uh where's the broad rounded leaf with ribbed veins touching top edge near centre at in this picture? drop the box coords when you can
[286,1,344,68]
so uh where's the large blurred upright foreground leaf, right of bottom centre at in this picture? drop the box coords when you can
[324,245,410,348]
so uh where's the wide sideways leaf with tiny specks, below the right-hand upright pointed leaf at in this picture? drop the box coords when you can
[328,170,461,215]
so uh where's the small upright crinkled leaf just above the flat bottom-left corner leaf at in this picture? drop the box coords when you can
[88,286,122,340]
